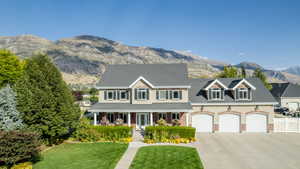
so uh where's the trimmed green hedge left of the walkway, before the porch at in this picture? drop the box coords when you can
[74,125,132,142]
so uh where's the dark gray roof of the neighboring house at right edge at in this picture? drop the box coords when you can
[271,83,300,97]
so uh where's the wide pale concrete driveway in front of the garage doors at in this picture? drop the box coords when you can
[196,133,300,169]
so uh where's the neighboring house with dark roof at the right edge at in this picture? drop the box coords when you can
[271,83,300,112]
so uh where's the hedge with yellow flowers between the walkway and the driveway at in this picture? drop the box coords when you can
[145,126,196,142]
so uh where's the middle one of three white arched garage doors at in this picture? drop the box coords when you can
[219,114,240,133]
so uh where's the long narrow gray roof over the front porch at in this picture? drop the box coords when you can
[89,103,192,112]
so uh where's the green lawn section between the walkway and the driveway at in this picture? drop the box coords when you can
[130,146,203,169]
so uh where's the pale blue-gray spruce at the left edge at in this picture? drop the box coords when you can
[0,85,23,131]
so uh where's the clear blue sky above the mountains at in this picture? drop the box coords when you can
[0,0,300,69]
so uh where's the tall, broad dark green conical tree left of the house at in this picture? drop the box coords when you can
[15,54,80,144]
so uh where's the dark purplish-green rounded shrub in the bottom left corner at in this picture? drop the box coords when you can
[0,131,41,166]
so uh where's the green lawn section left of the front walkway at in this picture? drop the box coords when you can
[33,143,128,169]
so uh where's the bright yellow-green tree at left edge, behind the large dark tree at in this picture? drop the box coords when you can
[0,49,24,87]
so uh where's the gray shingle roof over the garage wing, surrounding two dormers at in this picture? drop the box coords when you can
[189,78,276,103]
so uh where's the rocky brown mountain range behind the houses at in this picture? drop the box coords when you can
[0,35,300,85]
